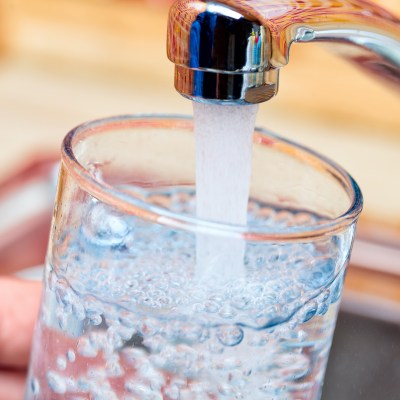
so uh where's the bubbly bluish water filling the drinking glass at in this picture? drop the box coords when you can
[31,191,354,400]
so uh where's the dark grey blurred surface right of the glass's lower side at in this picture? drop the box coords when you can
[322,312,400,400]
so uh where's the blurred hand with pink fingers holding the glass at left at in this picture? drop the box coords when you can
[0,277,41,400]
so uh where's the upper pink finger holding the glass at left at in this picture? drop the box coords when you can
[0,277,41,368]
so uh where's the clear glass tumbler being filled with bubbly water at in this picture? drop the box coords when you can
[25,116,362,400]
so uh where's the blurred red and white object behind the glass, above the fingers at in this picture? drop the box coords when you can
[0,157,58,274]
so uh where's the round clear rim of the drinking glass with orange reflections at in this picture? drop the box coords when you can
[61,114,363,242]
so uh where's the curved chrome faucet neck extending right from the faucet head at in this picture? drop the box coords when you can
[206,0,400,68]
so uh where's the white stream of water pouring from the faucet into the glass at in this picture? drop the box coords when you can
[193,102,258,282]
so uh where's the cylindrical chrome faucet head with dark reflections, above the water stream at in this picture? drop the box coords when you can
[167,0,279,104]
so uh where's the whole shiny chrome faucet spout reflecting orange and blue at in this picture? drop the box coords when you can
[167,0,400,104]
